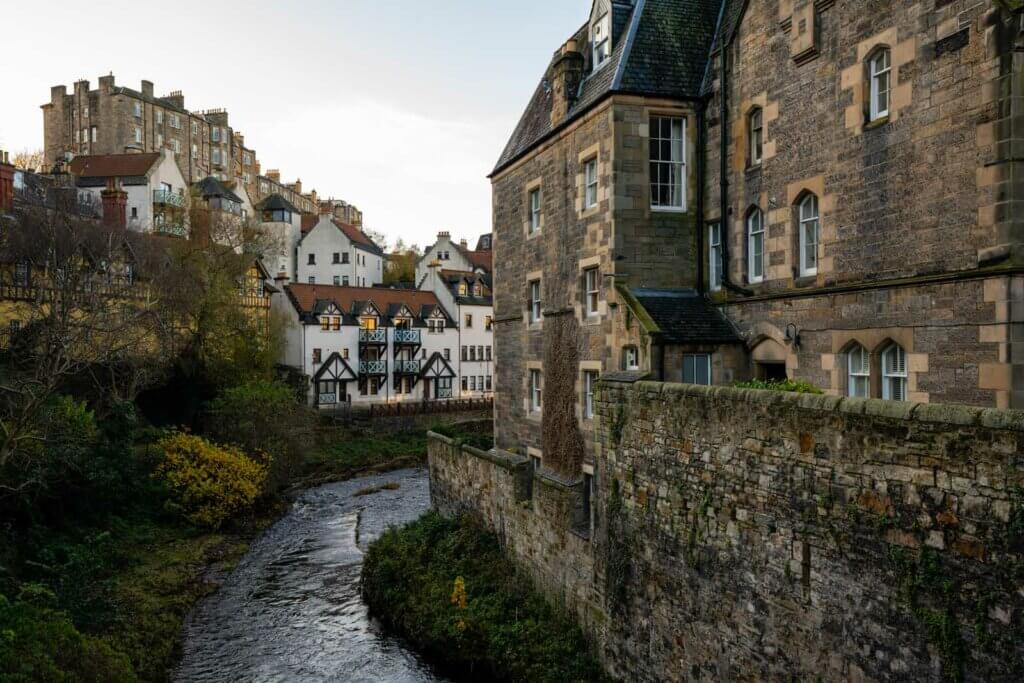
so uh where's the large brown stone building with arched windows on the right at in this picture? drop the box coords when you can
[492,0,1024,479]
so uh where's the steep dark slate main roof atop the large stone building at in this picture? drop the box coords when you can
[492,0,722,175]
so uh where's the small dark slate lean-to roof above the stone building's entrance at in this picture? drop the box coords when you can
[631,289,742,344]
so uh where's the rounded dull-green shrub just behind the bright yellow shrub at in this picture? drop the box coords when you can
[201,382,315,493]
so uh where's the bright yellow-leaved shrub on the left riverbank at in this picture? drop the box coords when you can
[157,432,267,528]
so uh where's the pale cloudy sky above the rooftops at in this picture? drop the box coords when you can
[0,0,591,247]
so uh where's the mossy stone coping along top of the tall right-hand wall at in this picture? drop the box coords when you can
[598,378,1024,432]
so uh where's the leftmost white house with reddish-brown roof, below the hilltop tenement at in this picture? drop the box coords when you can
[71,150,189,236]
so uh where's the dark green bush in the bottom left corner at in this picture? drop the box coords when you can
[0,585,136,683]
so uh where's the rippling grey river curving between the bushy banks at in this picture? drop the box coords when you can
[176,470,442,683]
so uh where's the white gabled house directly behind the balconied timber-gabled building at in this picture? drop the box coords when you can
[295,214,384,287]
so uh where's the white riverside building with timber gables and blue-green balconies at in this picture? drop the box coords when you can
[274,283,459,410]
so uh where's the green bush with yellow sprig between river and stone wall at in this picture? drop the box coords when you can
[362,513,606,683]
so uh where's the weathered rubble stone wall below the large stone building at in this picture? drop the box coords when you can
[430,382,1024,681]
